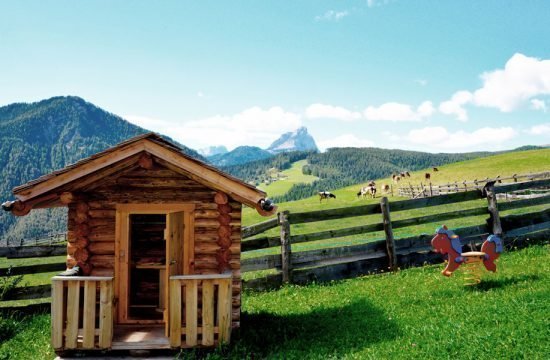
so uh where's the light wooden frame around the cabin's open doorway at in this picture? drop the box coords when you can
[114,203,195,324]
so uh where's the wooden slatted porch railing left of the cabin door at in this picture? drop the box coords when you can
[52,276,113,350]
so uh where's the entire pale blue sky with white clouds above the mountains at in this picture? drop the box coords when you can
[0,0,550,152]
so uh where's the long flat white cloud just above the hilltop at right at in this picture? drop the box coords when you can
[406,126,518,151]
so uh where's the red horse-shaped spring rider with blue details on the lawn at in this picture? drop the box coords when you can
[432,225,502,285]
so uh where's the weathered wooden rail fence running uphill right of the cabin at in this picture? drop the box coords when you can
[241,179,550,289]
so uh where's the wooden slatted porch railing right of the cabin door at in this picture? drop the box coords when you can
[169,273,231,347]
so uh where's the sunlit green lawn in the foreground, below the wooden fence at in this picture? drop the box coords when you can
[0,245,550,359]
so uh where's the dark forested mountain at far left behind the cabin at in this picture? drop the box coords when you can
[0,96,204,244]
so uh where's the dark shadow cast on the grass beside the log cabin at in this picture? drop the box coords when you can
[230,300,399,358]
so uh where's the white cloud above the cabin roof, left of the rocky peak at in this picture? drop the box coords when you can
[179,106,302,149]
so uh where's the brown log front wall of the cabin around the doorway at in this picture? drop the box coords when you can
[67,164,242,327]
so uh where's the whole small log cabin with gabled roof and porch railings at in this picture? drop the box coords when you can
[3,133,276,352]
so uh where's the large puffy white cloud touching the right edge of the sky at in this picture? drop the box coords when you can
[439,53,550,121]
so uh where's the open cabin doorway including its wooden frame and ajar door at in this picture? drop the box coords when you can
[115,204,195,326]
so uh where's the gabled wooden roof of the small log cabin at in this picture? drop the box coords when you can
[7,133,276,215]
